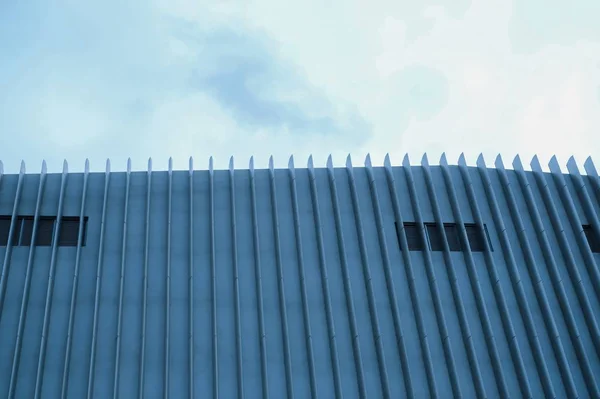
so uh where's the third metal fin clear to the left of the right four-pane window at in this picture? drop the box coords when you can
[327,155,367,398]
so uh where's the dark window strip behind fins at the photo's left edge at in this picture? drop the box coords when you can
[0,215,87,247]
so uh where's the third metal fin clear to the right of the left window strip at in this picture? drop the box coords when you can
[138,158,152,399]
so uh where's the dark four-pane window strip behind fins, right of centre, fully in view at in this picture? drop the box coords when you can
[396,222,490,252]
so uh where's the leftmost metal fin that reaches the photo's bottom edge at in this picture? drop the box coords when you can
[8,161,47,399]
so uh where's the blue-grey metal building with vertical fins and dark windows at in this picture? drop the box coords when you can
[0,157,600,398]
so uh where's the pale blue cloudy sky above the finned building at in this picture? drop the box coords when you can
[0,0,600,172]
